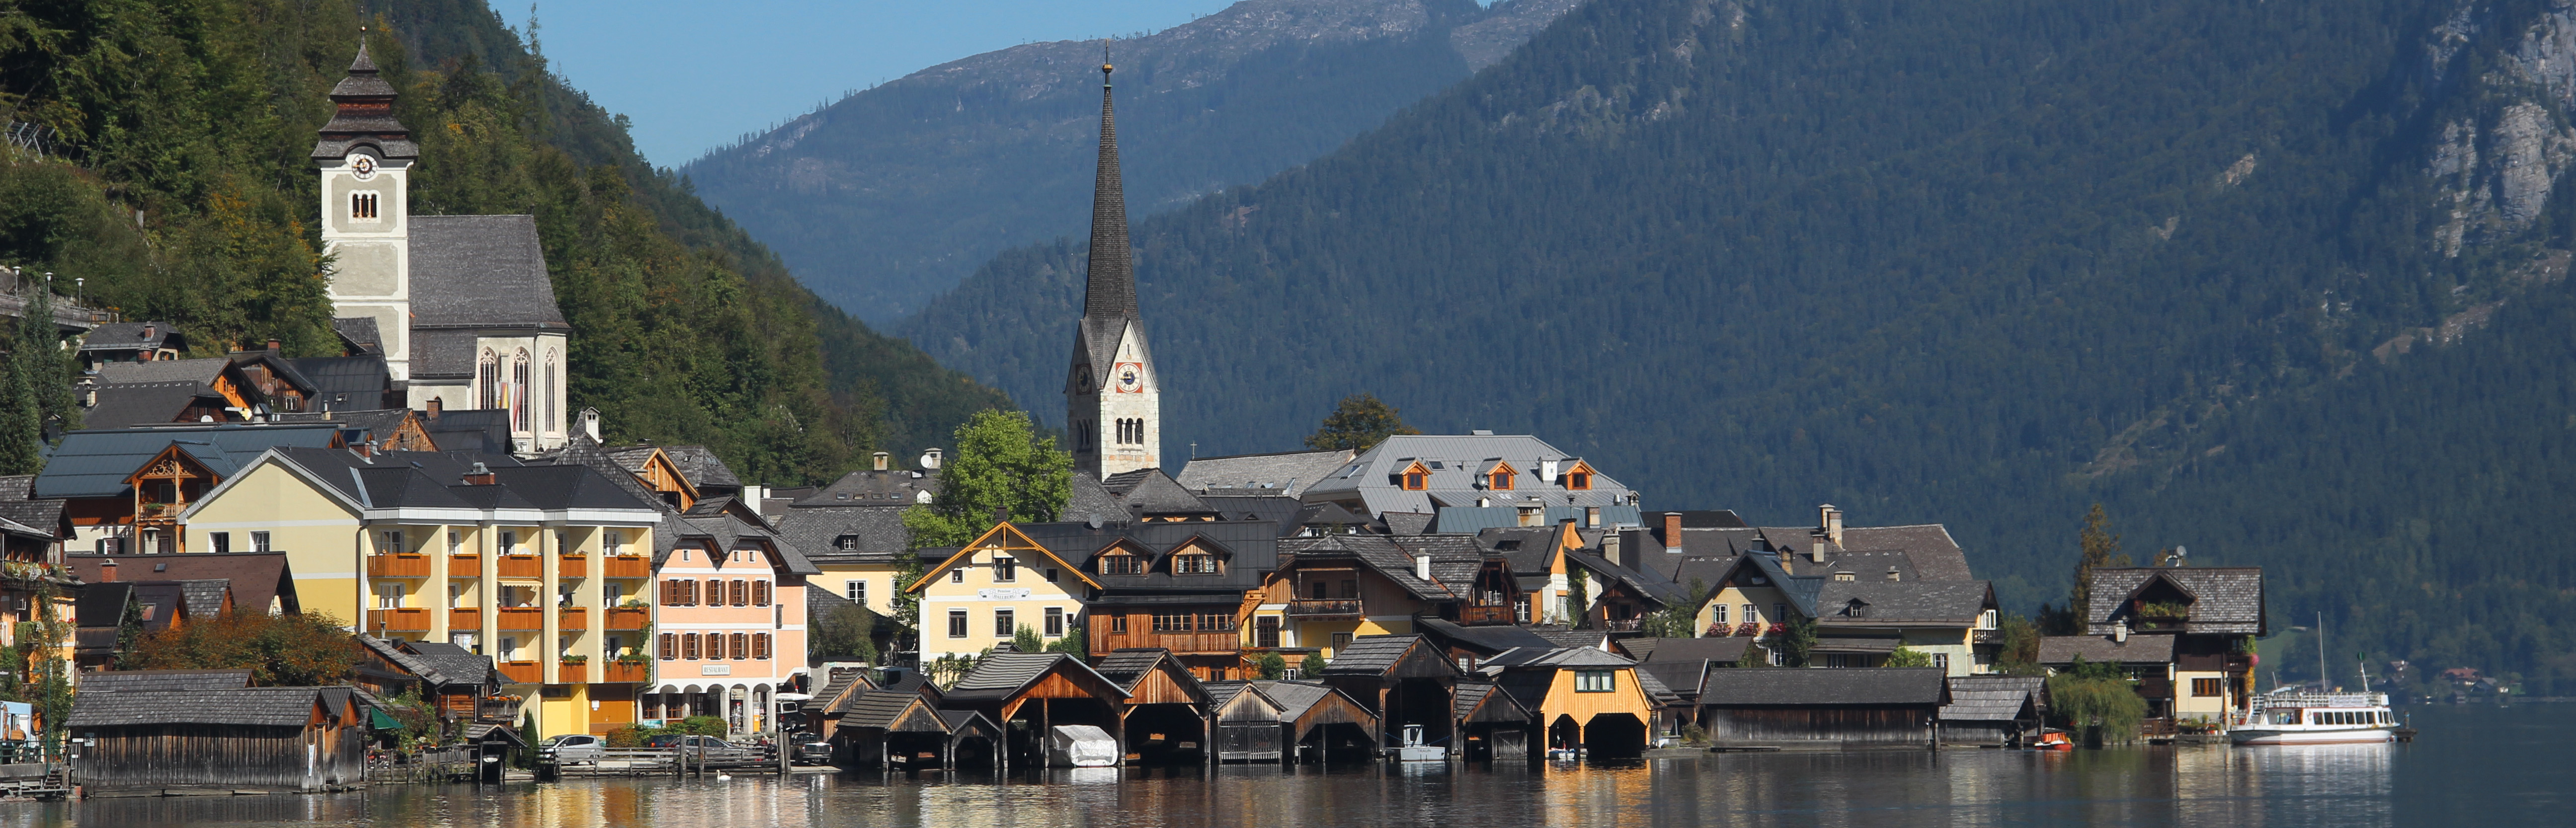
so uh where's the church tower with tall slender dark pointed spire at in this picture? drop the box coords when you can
[1064,64,1162,478]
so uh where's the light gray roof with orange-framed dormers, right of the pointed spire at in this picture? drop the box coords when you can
[1301,435,1630,514]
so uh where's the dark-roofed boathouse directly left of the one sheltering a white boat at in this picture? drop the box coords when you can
[832,674,1002,771]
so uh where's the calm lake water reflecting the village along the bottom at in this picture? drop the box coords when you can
[0,705,2576,828]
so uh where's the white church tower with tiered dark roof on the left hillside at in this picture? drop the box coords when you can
[314,41,420,388]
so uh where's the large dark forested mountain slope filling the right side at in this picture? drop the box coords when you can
[894,0,2576,692]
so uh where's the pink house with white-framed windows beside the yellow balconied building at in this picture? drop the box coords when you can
[636,512,822,733]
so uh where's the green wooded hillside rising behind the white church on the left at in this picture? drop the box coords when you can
[0,0,1007,483]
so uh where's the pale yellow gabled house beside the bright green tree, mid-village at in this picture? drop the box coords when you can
[906,522,1100,661]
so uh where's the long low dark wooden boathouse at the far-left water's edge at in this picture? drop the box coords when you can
[65,671,368,792]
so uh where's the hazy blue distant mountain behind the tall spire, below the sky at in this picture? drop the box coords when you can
[680,0,1582,321]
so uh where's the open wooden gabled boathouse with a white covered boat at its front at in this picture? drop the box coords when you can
[940,651,1128,769]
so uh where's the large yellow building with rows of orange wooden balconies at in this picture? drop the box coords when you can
[183,448,662,733]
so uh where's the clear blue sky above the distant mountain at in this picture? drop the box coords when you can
[533,0,1231,167]
